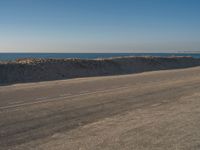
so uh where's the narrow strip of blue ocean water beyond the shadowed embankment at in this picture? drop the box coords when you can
[0,53,200,61]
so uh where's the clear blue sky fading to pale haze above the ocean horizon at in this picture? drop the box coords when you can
[0,0,200,52]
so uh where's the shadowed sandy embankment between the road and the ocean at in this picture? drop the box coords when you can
[0,57,200,84]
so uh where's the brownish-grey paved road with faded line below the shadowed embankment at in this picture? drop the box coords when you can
[0,67,200,150]
